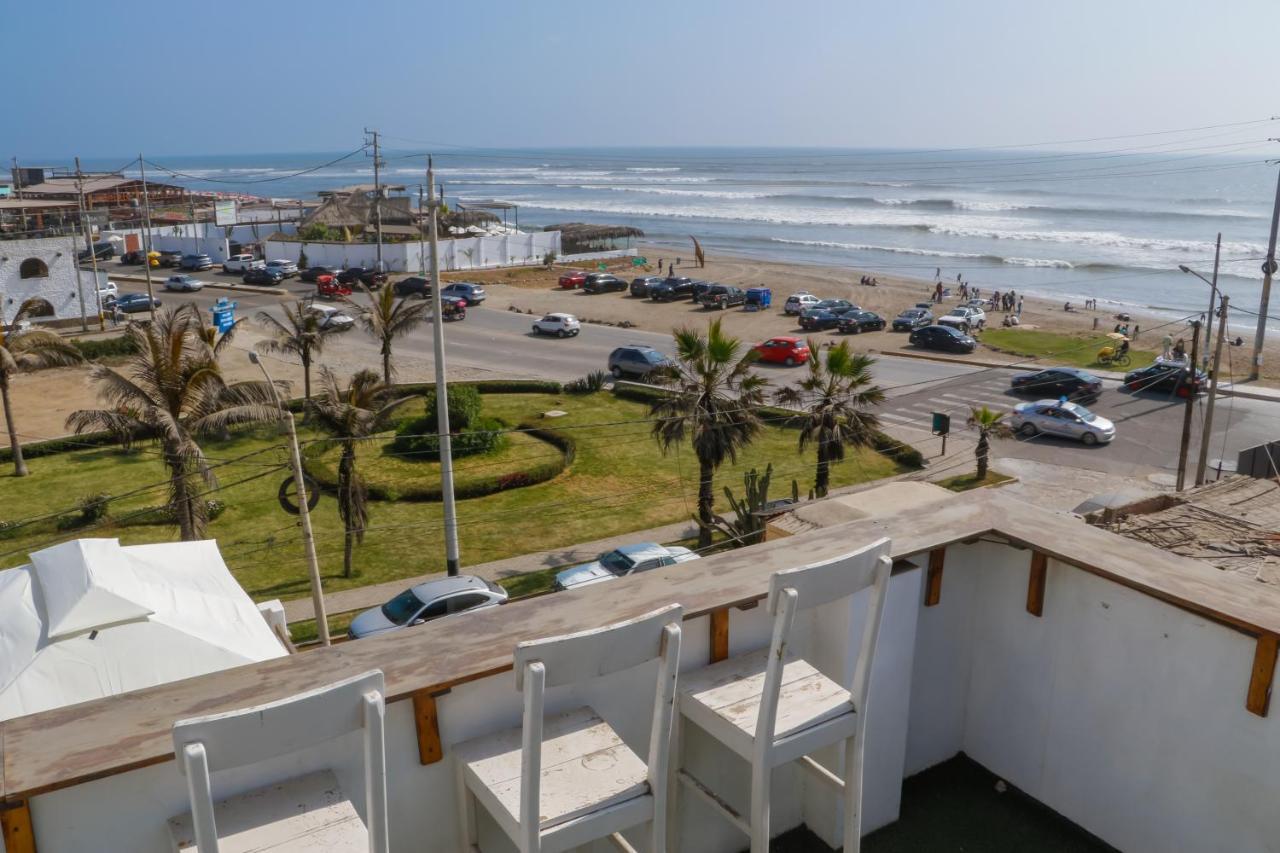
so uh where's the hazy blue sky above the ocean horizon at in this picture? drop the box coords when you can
[0,0,1280,160]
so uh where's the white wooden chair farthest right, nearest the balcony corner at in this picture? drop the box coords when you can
[671,539,892,853]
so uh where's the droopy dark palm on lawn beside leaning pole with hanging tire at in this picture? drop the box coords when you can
[308,368,413,578]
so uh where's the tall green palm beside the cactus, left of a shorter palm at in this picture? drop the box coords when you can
[649,320,767,547]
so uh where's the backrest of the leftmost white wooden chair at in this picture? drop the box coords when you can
[173,670,388,853]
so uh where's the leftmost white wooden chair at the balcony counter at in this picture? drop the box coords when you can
[169,670,390,853]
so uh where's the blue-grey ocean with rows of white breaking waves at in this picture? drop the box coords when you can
[93,144,1280,327]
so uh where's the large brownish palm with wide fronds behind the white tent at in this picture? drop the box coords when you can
[67,305,280,540]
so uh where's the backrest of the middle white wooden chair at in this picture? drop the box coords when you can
[515,605,684,850]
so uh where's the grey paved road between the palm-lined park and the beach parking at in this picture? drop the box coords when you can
[160,274,1280,478]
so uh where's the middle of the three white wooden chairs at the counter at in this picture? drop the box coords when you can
[454,605,682,853]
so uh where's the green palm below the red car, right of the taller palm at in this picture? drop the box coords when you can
[773,339,884,497]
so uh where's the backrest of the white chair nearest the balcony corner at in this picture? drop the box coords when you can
[755,538,893,748]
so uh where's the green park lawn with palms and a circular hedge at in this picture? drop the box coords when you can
[0,393,900,599]
